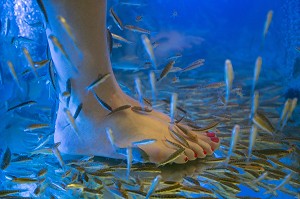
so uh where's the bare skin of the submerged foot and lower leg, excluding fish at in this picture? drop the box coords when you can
[43,0,219,163]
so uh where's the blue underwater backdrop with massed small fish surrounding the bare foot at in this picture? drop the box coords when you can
[0,0,300,198]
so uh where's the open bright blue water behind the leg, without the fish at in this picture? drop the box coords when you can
[0,0,300,198]
